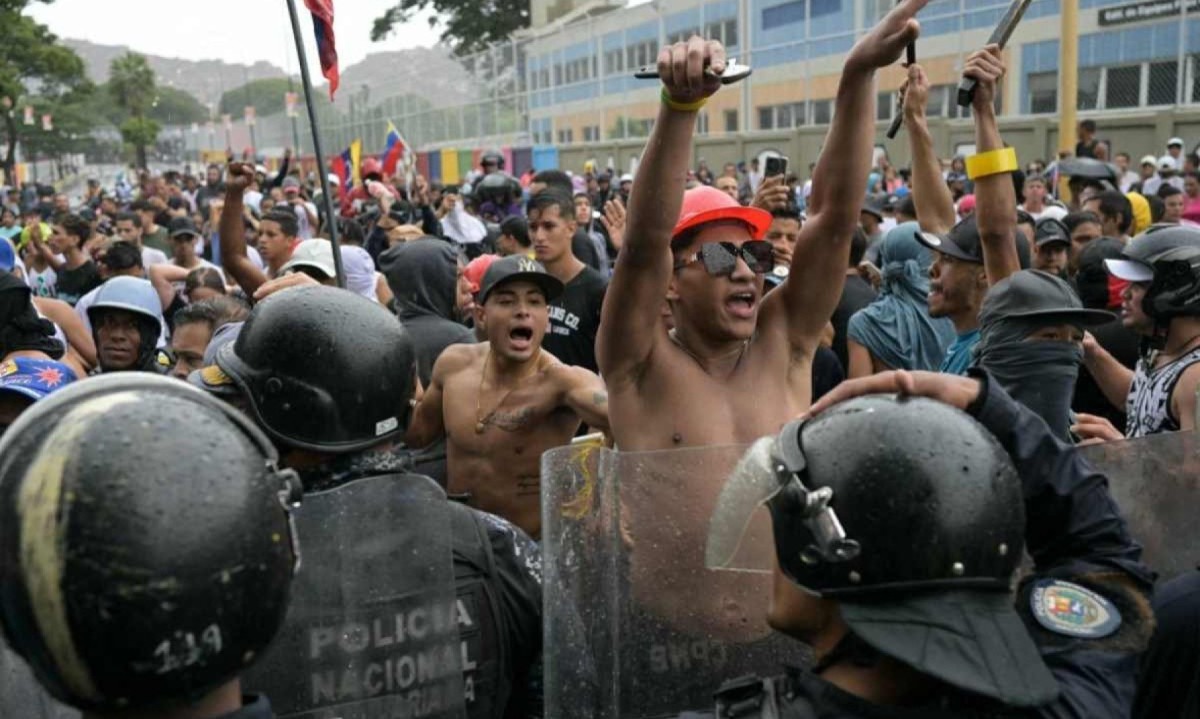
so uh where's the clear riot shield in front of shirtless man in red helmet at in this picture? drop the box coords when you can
[541,447,809,719]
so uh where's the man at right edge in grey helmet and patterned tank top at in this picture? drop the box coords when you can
[1084,227,1200,439]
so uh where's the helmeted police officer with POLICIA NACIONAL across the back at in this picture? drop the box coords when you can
[202,286,541,719]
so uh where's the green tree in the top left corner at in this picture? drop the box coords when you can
[0,0,90,184]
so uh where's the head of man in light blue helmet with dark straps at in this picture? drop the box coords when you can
[88,276,173,375]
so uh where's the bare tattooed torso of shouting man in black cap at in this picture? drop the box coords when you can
[443,343,580,538]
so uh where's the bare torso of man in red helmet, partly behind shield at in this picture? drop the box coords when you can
[608,336,812,642]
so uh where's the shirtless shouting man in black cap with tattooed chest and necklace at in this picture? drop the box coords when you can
[407,254,608,539]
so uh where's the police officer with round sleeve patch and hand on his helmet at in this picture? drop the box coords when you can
[708,371,1153,719]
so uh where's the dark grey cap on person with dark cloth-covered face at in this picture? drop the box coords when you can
[979,270,1116,326]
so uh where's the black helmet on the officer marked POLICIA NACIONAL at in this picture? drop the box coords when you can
[216,287,416,454]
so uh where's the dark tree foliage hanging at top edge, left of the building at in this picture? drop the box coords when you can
[371,0,529,56]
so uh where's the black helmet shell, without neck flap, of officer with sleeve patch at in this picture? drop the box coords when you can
[769,396,1025,597]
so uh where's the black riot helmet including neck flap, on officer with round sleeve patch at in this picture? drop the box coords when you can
[768,395,1057,706]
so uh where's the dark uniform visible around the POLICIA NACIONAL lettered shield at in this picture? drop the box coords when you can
[300,451,541,719]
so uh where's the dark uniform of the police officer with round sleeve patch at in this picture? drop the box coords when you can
[716,370,1153,719]
